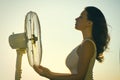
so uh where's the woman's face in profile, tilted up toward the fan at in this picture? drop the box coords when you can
[75,10,88,31]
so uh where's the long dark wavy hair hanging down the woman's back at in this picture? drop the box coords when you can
[85,6,110,62]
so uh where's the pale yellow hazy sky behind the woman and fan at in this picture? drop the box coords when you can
[0,0,120,80]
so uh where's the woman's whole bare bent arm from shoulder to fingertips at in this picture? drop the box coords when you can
[34,41,94,80]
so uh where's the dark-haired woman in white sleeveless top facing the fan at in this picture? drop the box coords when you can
[34,6,110,80]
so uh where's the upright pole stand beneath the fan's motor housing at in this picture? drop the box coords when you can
[15,49,25,80]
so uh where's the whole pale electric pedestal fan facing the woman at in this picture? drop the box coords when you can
[9,11,42,80]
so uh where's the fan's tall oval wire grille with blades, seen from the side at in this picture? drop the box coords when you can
[25,11,42,66]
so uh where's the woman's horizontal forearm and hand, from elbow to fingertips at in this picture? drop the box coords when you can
[34,65,80,80]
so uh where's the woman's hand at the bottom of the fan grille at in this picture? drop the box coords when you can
[33,65,51,79]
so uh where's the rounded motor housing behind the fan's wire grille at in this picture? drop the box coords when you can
[9,33,27,49]
